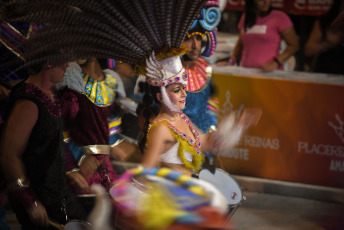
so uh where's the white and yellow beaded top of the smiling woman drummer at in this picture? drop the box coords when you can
[148,113,204,173]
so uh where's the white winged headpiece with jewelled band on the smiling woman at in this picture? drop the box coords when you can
[146,51,188,87]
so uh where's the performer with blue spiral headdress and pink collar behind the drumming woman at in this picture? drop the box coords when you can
[182,1,221,133]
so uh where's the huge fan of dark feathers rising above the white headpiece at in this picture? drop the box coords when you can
[0,0,206,72]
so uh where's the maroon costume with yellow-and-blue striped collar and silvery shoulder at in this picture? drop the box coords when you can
[58,63,121,193]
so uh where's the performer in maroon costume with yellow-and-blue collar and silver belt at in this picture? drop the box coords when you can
[58,58,132,198]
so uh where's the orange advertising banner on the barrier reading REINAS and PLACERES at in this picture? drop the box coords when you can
[213,73,344,188]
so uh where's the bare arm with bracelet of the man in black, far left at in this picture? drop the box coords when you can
[0,100,49,226]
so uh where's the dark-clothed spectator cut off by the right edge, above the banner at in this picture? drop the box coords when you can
[304,0,344,74]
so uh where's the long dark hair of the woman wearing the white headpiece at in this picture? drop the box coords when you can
[136,82,161,153]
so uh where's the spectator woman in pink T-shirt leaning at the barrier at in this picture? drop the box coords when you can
[218,0,299,72]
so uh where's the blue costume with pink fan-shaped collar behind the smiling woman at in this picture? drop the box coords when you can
[183,57,217,133]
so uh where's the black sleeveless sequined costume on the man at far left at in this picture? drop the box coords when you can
[8,83,83,229]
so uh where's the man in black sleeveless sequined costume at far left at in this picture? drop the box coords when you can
[0,51,85,230]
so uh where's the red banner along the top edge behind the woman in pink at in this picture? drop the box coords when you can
[226,0,333,15]
